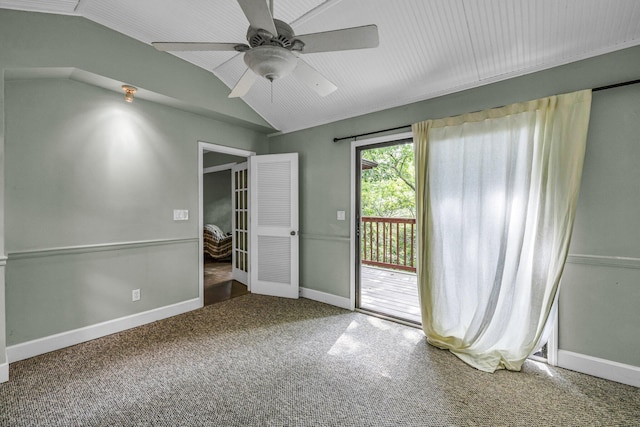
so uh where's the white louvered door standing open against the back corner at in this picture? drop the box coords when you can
[249,153,299,298]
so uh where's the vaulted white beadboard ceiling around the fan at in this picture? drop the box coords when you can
[0,0,640,132]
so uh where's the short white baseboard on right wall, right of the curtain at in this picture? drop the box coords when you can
[558,350,640,387]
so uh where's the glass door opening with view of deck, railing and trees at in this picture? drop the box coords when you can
[353,136,421,325]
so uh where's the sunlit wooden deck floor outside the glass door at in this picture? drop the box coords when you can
[359,266,422,324]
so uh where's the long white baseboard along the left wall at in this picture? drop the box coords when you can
[5,298,202,364]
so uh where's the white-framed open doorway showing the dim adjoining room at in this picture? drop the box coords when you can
[199,142,255,305]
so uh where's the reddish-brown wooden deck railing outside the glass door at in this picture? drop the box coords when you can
[360,216,416,272]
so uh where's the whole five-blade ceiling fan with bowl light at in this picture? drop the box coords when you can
[151,0,378,98]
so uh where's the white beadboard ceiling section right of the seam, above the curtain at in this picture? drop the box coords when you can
[464,0,640,79]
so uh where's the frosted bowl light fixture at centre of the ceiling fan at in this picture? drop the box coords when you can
[244,45,298,81]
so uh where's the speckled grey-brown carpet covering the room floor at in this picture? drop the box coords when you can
[0,295,640,426]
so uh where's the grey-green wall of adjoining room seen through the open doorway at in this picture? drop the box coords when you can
[202,169,231,233]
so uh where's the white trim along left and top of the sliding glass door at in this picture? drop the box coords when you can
[349,132,413,310]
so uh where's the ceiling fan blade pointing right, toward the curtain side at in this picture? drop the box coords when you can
[296,24,379,53]
